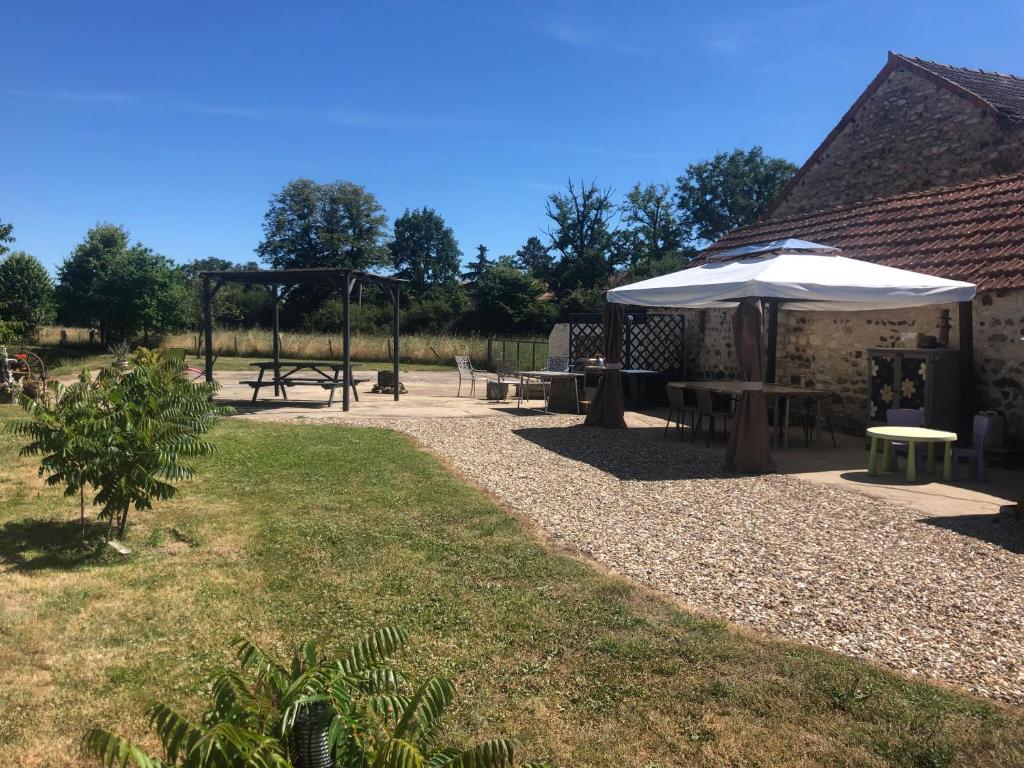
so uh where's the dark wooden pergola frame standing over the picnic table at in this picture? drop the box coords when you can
[202,268,407,411]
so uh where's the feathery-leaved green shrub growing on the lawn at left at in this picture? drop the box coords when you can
[11,348,228,537]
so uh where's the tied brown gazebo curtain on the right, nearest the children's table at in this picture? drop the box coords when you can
[725,299,772,473]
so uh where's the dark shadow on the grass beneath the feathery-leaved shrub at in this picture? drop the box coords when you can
[0,517,113,571]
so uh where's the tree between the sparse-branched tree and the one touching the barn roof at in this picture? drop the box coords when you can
[616,184,682,268]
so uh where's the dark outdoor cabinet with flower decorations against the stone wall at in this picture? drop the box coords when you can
[867,348,961,432]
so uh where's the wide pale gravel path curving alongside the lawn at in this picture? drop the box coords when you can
[345,416,1024,703]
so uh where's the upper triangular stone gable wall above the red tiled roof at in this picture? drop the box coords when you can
[771,69,1024,218]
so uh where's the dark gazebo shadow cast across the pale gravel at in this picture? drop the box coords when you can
[512,425,738,481]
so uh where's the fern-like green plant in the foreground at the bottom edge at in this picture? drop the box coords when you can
[83,628,557,768]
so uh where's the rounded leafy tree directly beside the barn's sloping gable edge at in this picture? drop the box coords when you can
[676,146,797,242]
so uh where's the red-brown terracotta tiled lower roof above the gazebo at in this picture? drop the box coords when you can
[706,173,1024,290]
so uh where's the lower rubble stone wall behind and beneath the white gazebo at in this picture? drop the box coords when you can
[684,291,1024,449]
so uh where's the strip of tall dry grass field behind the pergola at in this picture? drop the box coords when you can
[39,326,547,368]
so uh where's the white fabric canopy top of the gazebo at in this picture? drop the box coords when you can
[607,239,975,311]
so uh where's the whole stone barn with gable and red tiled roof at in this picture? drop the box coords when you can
[686,53,1024,447]
